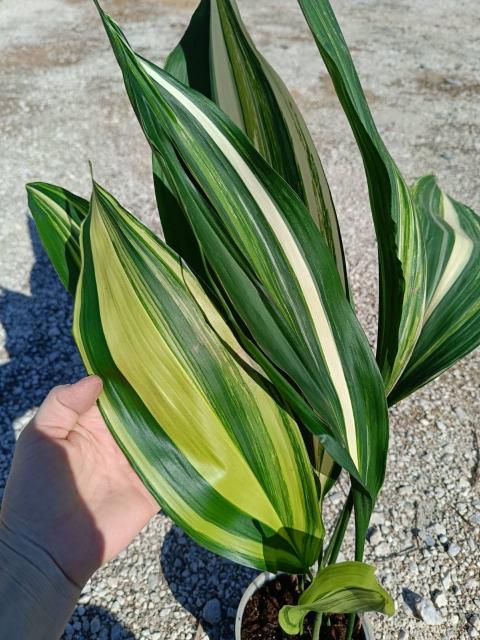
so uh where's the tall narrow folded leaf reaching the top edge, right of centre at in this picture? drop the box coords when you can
[298,0,426,392]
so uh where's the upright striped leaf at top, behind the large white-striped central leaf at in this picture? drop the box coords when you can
[163,0,348,290]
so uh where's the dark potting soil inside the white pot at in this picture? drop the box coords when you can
[242,575,365,640]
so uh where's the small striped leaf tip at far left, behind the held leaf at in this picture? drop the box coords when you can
[26,182,89,295]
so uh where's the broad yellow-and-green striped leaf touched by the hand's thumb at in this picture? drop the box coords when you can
[74,185,323,573]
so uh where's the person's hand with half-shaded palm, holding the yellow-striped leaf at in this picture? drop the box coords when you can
[0,376,159,587]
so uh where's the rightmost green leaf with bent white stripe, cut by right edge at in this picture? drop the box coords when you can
[389,176,480,403]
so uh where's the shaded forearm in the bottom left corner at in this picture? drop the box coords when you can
[0,524,80,640]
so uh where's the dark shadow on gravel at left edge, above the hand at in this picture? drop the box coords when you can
[0,218,85,491]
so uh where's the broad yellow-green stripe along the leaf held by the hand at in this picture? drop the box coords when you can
[91,194,281,530]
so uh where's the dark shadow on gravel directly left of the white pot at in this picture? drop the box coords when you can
[161,526,257,640]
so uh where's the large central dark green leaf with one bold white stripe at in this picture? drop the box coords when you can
[94,3,388,521]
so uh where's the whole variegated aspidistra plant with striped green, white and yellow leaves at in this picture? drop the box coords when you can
[27,0,480,638]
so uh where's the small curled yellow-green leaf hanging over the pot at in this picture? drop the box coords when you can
[278,562,395,635]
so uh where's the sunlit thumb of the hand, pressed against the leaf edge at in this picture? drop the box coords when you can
[35,376,103,430]
